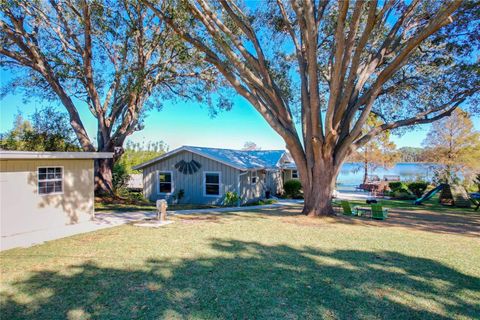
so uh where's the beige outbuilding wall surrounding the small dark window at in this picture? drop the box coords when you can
[0,159,94,236]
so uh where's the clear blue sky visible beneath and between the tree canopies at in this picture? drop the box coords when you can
[0,71,480,149]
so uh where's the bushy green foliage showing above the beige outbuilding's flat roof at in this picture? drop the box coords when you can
[0,107,80,151]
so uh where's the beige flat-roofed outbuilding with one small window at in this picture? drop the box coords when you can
[0,150,113,237]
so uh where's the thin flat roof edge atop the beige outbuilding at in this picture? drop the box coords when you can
[0,150,113,160]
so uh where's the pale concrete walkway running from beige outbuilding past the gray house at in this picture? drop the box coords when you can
[0,200,303,251]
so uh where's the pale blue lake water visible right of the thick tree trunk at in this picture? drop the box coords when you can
[337,162,433,186]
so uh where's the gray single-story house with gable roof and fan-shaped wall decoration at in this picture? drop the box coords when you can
[133,146,298,204]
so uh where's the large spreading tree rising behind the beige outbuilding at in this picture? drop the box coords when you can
[0,0,219,192]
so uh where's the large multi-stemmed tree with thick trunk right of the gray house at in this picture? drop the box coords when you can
[143,0,479,216]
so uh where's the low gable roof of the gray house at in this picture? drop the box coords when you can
[133,146,285,170]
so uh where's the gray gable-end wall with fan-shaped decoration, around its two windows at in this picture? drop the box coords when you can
[143,151,240,204]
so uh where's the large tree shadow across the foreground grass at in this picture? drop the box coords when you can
[1,239,480,319]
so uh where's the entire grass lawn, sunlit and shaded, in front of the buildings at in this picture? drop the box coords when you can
[0,207,480,319]
